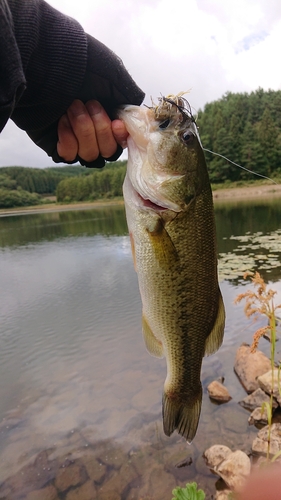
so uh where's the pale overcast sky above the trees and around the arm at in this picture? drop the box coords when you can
[0,0,281,167]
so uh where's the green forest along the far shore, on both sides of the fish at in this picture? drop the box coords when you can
[0,88,281,208]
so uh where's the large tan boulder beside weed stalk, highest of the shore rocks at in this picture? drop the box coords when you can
[234,344,271,393]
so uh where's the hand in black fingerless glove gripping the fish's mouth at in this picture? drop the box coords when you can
[21,28,144,168]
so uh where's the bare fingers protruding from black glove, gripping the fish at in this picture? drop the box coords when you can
[57,99,128,163]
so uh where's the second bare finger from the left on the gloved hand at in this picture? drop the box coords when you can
[67,99,99,162]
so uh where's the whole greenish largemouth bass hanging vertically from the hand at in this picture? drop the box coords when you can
[119,93,225,443]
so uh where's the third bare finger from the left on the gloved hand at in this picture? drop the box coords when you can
[86,101,117,158]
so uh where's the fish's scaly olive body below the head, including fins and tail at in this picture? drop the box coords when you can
[124,176,224,442]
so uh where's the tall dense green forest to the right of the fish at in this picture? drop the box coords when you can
[197,88,281,183]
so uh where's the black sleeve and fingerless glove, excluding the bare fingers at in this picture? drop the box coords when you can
[0,0,144,166]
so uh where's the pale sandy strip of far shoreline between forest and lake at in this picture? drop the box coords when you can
[0,184,281,217]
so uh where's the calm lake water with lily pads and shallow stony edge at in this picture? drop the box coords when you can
[0,199,281,500]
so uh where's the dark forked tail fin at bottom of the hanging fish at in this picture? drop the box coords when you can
[162,387,202,443]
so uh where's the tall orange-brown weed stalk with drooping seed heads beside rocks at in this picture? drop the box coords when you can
[235,271,281,461]
